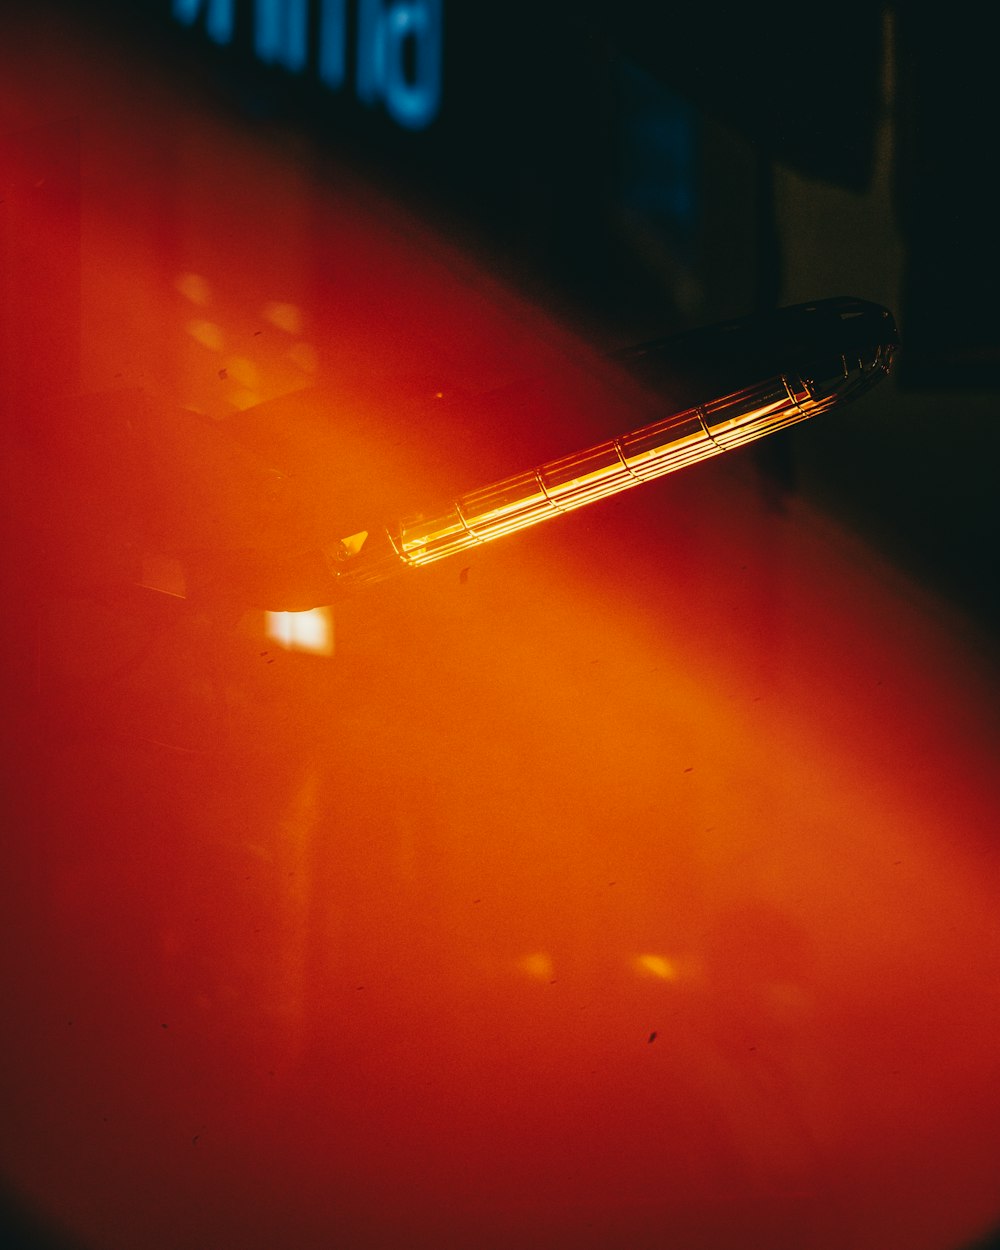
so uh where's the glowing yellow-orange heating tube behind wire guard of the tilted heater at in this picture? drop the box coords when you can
[338,300,895,584]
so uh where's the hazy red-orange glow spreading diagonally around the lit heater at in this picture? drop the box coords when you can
[0,9,1000,1250]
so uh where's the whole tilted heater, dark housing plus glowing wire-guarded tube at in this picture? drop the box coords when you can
[324,298,899,594]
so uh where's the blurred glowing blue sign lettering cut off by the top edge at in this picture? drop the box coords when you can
[171,0,443,130]
